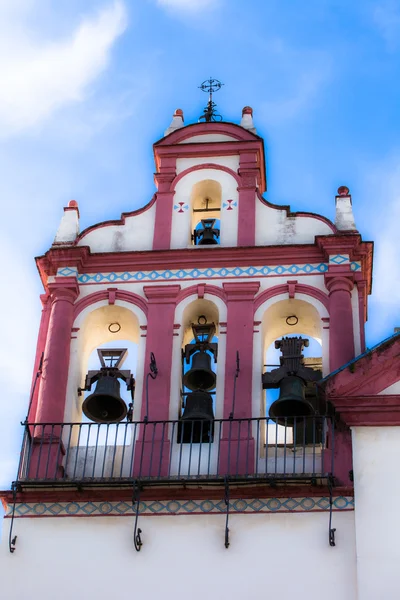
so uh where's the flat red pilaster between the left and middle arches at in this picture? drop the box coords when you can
[133,285,180,477]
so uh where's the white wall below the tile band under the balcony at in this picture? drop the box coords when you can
[0,512,356,600]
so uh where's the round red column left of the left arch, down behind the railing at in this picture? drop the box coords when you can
[29,277,79,479]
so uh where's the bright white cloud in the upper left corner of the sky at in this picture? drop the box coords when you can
[0,0,127,135]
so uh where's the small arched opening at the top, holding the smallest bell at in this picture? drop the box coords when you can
[190,179,222,246]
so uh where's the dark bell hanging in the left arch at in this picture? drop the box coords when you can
[82,375,127,423]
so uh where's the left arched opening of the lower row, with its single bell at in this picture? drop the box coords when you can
[64,305,139,479]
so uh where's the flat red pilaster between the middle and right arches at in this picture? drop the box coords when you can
[219,281,260,475]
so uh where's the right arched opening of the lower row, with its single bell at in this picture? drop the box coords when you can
[260,297,326,474]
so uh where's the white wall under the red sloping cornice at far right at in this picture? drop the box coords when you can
[354,427,400,600]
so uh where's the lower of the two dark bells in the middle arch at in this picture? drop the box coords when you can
[178,390,214,444]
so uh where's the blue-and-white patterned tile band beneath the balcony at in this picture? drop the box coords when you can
[6,496,354,518]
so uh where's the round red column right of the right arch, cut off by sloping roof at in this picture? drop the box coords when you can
[325,274,354,372]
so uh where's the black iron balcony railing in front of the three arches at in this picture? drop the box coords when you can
[17,416,333,485]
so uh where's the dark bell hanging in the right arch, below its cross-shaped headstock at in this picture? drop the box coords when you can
[269,375,315,426]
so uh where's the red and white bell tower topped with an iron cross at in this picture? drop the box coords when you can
[2,79,400,600]
